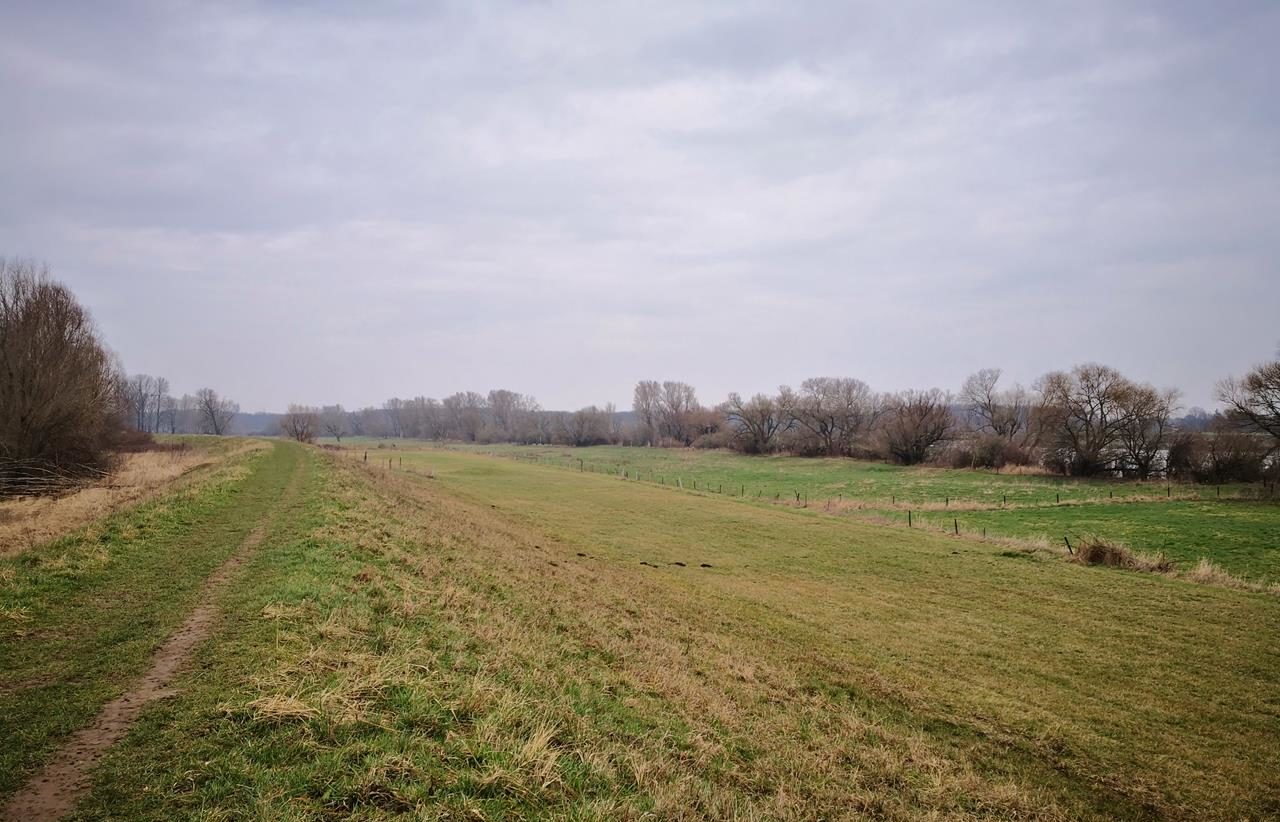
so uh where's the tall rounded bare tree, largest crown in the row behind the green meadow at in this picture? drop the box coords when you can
[1039,362,1134,476]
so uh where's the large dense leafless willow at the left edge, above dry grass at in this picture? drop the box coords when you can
[0,257,124,490]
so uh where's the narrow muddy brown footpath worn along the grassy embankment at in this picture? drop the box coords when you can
[0,448,306,822]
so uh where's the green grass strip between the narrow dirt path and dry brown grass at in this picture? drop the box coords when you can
[0,437,300,796]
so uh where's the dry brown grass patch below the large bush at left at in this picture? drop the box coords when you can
[0,440,264,557]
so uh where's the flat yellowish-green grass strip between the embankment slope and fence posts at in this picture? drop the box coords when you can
[381,451,1280,816]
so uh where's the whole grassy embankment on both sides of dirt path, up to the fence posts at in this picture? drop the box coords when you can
[0,443,1280,819]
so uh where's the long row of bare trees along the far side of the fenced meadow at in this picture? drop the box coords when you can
[282,362,1280,483]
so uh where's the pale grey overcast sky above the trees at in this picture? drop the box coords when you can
[0,0,1280,410]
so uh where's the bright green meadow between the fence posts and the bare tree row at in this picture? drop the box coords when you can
[417,443,1280,583]
